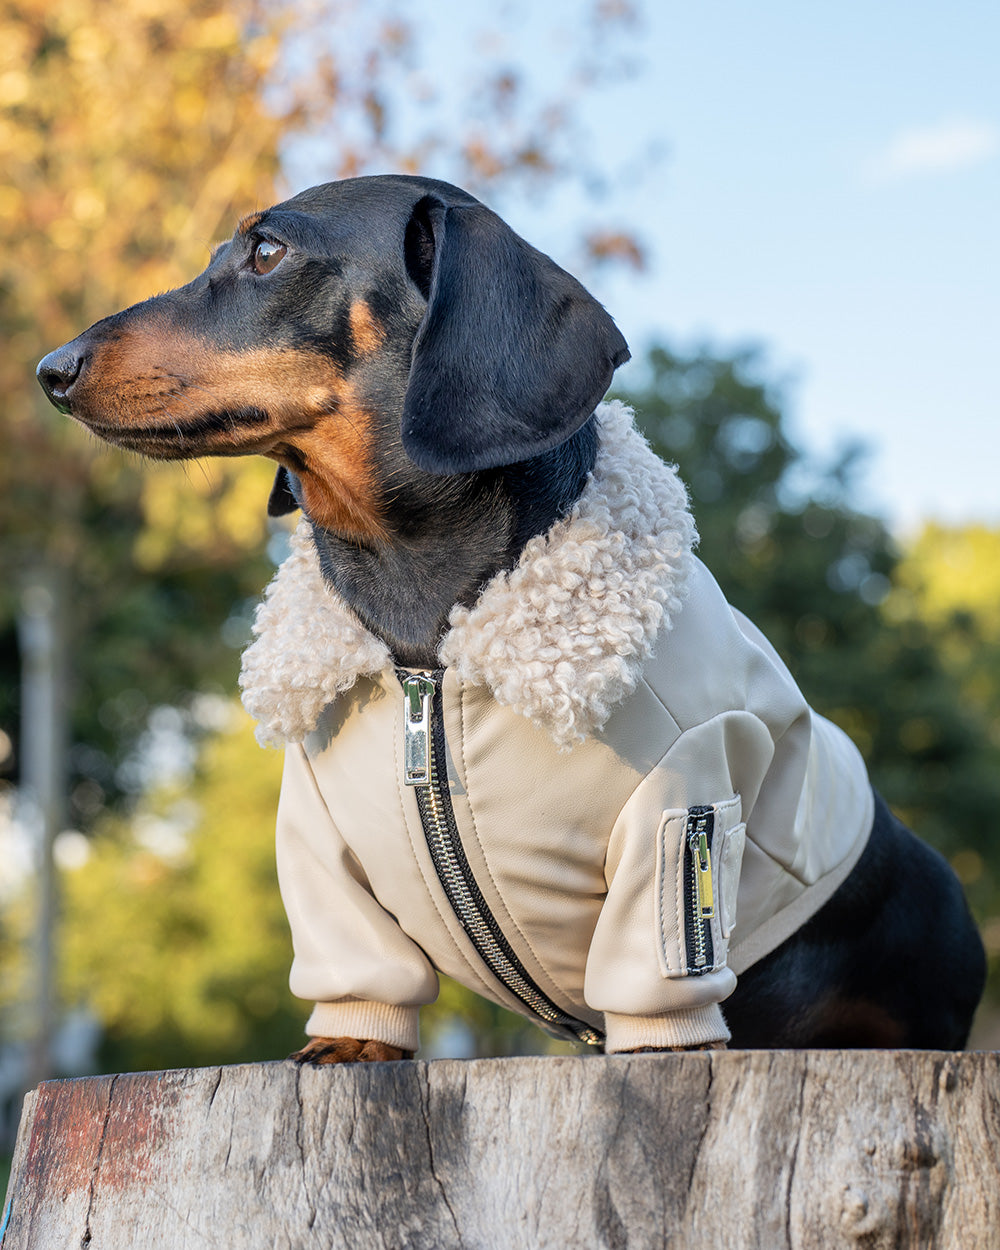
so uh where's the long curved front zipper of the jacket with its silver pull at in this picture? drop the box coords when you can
[399,669,604,1046]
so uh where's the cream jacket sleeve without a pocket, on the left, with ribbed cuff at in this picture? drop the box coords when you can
[278,745,438,1050]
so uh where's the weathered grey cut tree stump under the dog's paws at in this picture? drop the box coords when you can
[0,1051,1000,1250]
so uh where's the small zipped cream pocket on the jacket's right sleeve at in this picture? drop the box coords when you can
[656,795,746,978]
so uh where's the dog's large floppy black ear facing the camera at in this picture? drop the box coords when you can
[403,196,629,474]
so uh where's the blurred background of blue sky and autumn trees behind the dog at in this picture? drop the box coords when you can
[0,0,1000,1170]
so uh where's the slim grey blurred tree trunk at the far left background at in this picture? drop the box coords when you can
[18,563,69,1088]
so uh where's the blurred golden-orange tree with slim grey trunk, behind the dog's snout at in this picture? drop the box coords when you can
[0,0,297,1079]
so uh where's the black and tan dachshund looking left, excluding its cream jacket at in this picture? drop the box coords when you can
[38,176,984,1063]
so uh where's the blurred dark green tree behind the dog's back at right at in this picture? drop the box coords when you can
[628,348,1000,890]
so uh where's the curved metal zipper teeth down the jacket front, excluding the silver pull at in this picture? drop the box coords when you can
[404,670,604,1046]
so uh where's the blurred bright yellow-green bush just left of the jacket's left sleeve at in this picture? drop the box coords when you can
[60,704,295,1071]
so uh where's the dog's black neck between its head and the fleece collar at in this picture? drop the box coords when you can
[313,418,598,668]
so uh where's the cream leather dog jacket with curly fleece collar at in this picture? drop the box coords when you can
[243,404,873,1051]
